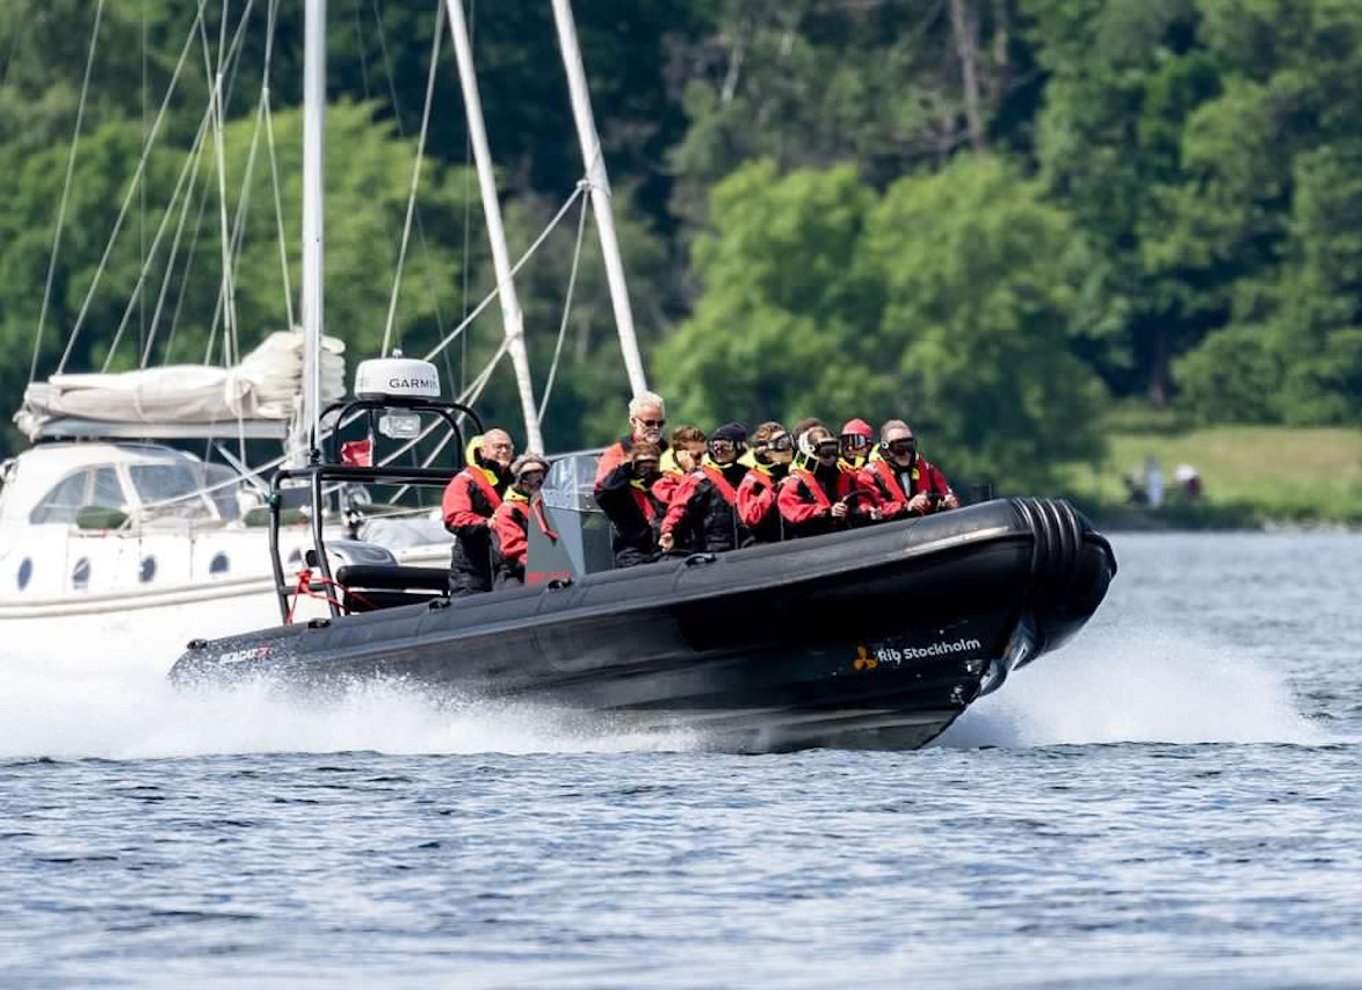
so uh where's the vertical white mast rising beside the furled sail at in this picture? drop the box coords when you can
[301,0,327,458]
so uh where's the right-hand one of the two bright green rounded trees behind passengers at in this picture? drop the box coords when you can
[862,157,1102,490]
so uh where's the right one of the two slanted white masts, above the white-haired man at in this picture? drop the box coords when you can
[553,0,648,394]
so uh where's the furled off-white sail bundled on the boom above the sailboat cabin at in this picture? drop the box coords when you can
[14,330,346,438]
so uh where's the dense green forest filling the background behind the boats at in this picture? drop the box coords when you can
[0,0,1362,485]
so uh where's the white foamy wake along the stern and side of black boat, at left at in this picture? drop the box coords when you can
[0,631,696,760]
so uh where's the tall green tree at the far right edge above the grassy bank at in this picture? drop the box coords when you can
[1170,0,1362,424]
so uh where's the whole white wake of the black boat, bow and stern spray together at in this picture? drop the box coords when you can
[0,624,1331,760]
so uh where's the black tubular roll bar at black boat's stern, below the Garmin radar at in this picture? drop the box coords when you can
[270,395,484,622]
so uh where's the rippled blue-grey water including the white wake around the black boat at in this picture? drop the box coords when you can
[0,535,1362,987]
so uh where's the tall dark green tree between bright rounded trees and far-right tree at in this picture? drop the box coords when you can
[1023,0,1226,403]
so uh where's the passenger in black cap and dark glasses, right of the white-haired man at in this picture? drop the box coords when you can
[658,422,752,553]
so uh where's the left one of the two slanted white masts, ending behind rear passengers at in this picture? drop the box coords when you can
[444,0,543,451]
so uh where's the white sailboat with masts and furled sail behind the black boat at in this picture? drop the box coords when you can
[0,0,646,660]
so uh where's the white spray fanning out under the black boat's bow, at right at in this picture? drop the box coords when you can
[937,624,1332,749]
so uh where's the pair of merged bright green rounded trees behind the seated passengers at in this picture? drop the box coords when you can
[656,157,1102,490]
